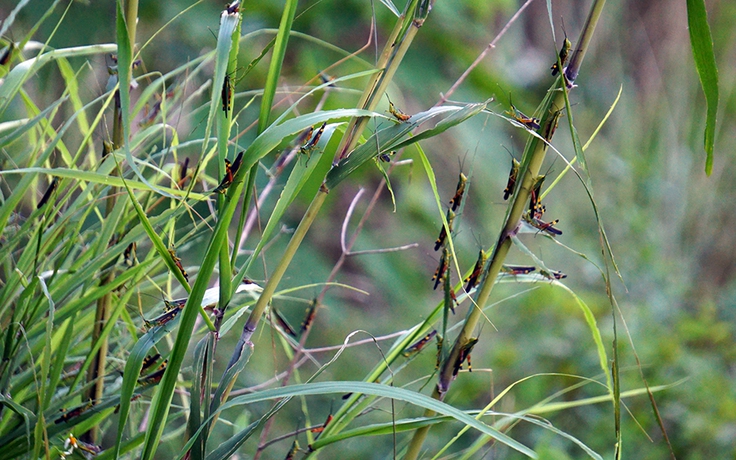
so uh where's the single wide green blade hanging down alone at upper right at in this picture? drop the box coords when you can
[687,0,718,176]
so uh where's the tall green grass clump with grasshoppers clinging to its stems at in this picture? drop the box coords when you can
[0,0,720,459]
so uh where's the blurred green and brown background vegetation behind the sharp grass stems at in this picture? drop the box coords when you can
[7,0,736,459]
